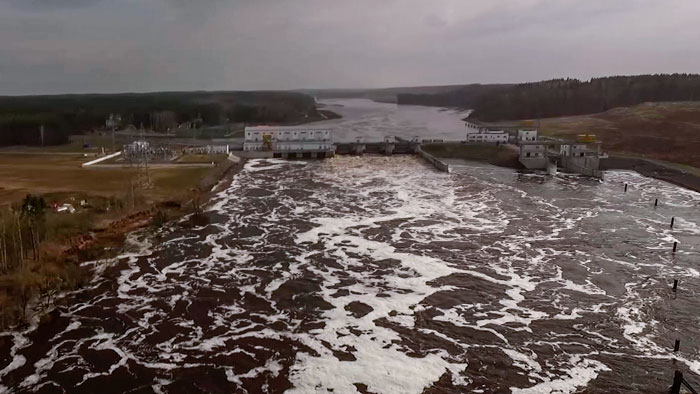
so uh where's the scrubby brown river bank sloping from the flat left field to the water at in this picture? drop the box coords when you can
[0,155,245,330]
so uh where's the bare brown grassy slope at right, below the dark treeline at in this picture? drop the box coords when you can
[540,102,700,168]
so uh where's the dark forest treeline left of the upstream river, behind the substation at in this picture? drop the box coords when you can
[0,91,318,146]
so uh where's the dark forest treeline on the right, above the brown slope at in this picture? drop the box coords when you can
[398,74,700,121]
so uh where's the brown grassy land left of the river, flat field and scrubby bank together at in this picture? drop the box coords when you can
[0,150,241,330]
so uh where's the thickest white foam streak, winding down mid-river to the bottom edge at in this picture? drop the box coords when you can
[289,159,482,393]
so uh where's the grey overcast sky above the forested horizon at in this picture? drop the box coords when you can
[0,0,700,95]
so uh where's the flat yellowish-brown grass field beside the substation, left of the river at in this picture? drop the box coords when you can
[0,152,210,206]
